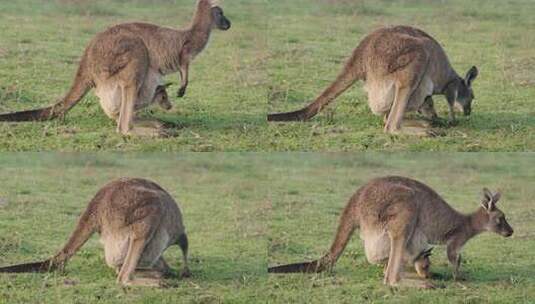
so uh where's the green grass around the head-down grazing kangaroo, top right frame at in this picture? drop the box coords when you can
[266,0,535,151]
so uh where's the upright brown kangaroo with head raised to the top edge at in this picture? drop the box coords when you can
[0,0,231,136]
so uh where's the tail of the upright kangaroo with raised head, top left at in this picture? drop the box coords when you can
[0,55,93,121]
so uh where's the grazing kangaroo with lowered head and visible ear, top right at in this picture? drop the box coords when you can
[268,26,478,136]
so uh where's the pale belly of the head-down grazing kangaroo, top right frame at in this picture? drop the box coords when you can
[364,79,396,115]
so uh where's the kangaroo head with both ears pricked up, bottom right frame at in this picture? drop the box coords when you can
[481,188,513,237]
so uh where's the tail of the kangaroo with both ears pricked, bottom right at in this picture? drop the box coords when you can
[268,204,358,273]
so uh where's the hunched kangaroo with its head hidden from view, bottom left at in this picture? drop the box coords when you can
[0,178,190,286]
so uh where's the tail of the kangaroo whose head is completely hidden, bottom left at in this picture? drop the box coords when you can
[0,200,97,273]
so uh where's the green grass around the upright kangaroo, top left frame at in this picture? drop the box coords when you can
[0,0,267,151]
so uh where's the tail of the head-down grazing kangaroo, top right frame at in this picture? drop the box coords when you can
[268,63,360,121]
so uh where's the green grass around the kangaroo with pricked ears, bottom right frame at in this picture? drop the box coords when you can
[268,153,535,303]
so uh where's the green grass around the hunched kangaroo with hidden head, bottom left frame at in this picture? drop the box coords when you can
[0,154,270,303]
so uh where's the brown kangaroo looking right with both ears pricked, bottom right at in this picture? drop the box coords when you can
[268,176,513,288]
